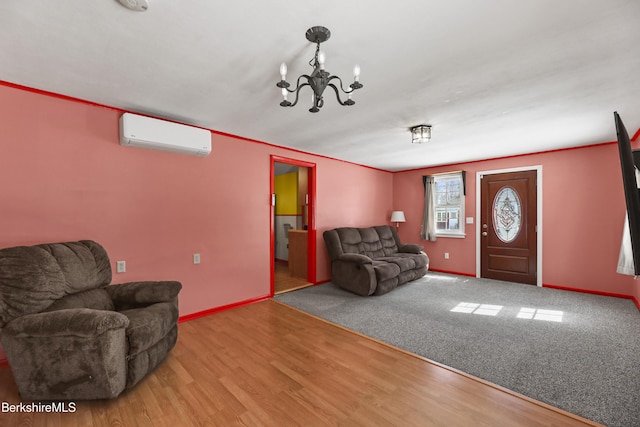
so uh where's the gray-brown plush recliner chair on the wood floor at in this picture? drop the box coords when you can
[0,240,182,400]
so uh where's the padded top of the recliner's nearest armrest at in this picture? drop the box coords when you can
[2,308,129,338]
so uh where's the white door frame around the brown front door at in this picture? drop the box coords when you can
[476,165,542,287]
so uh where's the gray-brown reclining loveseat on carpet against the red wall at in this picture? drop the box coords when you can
[323,225,429,296]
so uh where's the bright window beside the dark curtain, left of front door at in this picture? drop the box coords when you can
[433,172,464,237]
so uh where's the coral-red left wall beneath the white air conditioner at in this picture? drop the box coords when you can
[0,84,393,358]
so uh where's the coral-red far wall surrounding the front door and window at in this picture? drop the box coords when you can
[393,142,640,300]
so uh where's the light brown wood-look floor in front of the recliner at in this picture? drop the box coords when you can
[0,300,597,427]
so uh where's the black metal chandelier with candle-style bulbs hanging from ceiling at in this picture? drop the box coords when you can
[276,27,362,113]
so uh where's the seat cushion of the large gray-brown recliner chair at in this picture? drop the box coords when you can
[120,302,178,357]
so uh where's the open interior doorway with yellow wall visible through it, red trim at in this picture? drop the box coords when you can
[271,156,316,295]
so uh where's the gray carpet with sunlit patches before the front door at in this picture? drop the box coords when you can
[275,272,640,427]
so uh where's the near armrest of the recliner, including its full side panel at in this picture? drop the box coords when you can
[0,308,129,400]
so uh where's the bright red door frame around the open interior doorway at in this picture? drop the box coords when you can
[269,154,316,297]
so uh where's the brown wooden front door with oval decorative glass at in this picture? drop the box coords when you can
[480,170,538,285]
